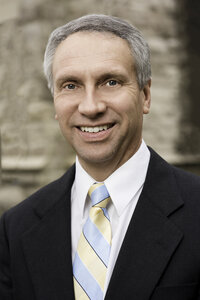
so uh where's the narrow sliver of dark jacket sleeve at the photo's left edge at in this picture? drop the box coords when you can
[0,214,14,300]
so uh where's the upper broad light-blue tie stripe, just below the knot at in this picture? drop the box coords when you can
[83,218,110,267]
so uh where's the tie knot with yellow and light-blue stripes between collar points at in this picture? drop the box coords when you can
[88,183,110,208]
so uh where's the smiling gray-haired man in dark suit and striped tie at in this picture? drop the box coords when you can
[0,15,200,300]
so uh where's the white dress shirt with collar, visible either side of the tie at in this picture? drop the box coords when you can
[71,141,150,295]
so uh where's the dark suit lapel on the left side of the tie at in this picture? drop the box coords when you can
[22,165,74,300]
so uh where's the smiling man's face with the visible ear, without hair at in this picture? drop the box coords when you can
[53,32,150,169]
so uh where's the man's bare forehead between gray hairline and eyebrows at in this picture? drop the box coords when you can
[53,32,133,79]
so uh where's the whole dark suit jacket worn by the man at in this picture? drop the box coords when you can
[0,150,200,300]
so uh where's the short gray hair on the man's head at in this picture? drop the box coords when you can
[44,14,151,94]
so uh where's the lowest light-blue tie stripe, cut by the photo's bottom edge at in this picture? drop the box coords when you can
[73,253,103,300]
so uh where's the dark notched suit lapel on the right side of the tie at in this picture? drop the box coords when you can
[105,151,183,300]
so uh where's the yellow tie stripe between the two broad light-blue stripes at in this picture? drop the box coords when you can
[77,234,107,291]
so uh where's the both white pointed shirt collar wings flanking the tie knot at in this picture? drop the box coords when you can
[74,141,150,216]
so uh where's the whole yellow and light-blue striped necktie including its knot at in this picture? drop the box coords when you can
[73,183,111,300]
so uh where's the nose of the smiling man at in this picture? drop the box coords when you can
[78,89,106,118]
